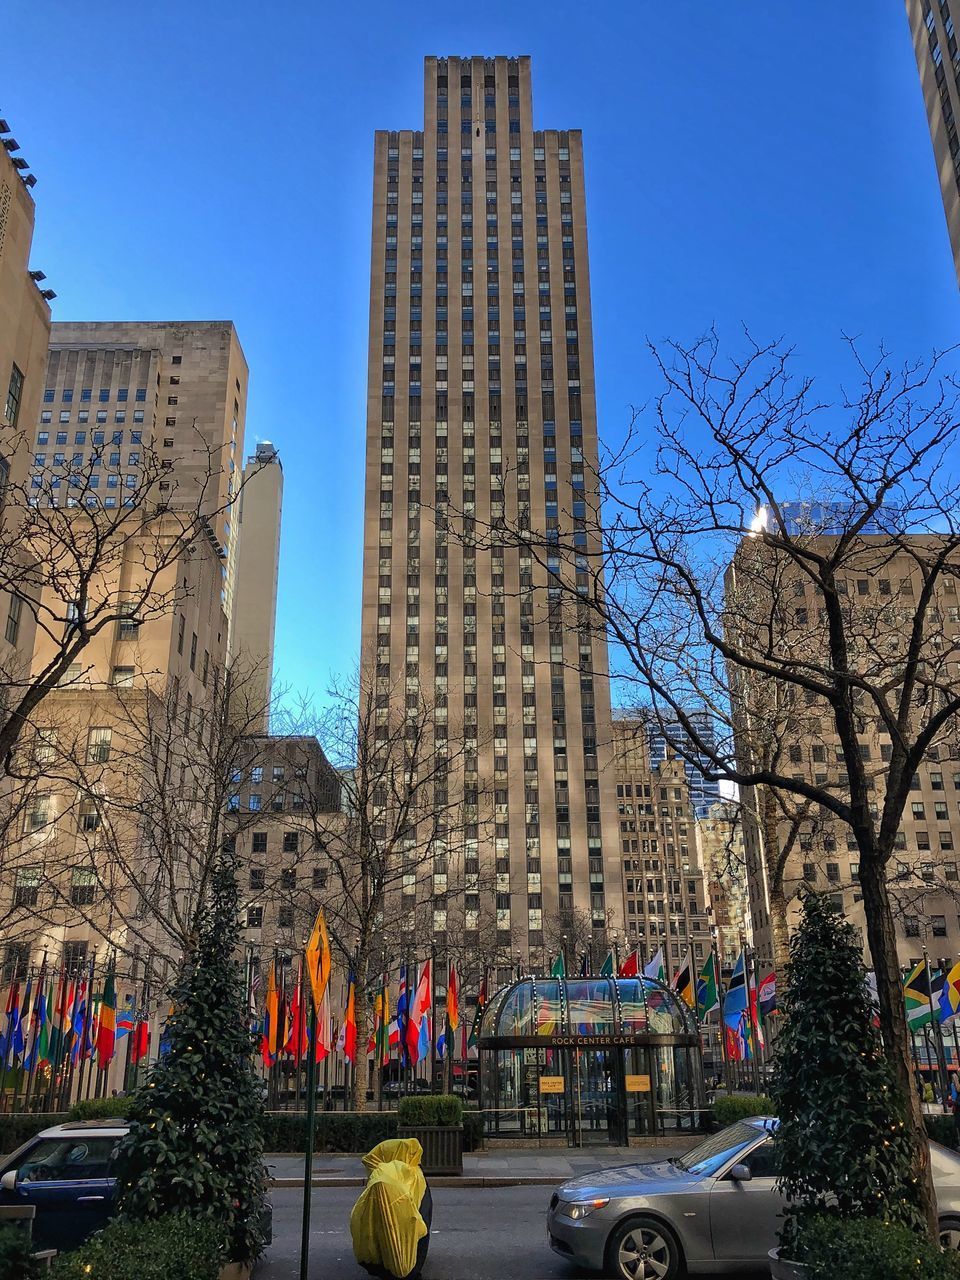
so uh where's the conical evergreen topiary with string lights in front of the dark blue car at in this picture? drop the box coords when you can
[118,852,265,1262]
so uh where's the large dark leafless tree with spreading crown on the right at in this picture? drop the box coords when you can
[478,334,960,1222]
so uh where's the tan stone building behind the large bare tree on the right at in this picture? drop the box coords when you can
[726,532,960,965]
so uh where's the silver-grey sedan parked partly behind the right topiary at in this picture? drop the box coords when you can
[547,1116,960,1280]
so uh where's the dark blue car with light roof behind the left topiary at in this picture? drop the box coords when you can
[0,1120,273,1251]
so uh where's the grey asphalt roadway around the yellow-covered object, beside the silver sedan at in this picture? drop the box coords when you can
[255,1187,768,1280]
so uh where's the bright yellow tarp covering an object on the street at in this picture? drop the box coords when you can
[349,1138,426,1280]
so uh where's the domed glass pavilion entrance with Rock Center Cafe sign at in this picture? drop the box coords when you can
[479,978,705,1147]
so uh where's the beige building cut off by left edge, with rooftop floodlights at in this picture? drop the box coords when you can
[0,120,52,678]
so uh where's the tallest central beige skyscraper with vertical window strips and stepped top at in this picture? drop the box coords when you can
[362,58,623,959]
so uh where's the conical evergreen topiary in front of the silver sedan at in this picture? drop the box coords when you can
[771,893,924,1256]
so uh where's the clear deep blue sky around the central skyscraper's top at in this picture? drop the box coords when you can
[0,0,960,692]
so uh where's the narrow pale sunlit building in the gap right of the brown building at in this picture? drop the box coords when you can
[696,800,751,972]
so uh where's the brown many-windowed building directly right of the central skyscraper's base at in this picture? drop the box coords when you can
[613,719,712,975]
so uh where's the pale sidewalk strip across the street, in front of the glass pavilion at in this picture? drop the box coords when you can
[264,1134,703,1187]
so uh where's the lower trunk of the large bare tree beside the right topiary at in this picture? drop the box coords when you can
[860,847,937,1239]
